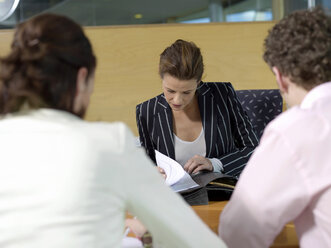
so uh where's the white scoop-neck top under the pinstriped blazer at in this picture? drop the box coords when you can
[174,128,206,167]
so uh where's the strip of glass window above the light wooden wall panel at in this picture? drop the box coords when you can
[0,0,331,28]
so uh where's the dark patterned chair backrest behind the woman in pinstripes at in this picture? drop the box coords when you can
[236,89,283,139]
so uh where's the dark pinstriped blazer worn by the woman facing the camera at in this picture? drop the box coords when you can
[136,82,258,176]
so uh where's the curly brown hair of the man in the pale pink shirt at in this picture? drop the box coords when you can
[263,7,331,90]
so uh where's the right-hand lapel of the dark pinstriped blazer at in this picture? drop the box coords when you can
[197,82,217,158]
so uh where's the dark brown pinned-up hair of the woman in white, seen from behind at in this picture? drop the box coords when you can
[0,14,96,114]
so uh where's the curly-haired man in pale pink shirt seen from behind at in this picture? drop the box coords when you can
[219,8,331,248]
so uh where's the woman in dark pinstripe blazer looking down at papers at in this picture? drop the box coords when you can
[136,40,258,176]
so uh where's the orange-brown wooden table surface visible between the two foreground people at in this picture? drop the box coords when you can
[192,201,299,248]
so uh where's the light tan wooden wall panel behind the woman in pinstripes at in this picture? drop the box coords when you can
[0,22,277,134]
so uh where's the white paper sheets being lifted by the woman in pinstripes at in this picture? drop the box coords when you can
[155,150,200,192]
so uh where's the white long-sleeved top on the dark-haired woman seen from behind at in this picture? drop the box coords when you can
[0,109,225,248]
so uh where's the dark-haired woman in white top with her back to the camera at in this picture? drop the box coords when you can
[0,14,225,248]
